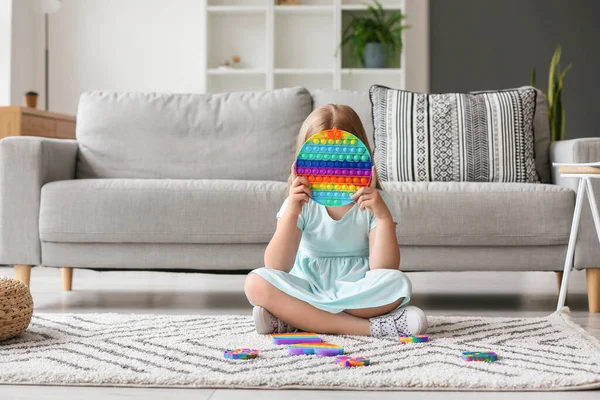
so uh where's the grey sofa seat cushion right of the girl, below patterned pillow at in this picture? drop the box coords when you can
[382,182,575,246]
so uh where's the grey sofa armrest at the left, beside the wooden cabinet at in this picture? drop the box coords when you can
[0,136,77,265]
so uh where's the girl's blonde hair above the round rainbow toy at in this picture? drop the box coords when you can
[287,104,382,192]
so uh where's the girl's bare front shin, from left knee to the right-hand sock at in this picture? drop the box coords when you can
[245,273,370,336]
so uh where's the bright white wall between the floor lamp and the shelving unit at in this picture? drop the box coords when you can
[35,0,205,114]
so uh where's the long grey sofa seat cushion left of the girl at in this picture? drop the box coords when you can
[40,179,286,243]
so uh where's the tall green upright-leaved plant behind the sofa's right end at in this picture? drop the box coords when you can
[531,45,573,142]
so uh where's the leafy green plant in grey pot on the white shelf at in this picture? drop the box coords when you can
[340,0,409,68]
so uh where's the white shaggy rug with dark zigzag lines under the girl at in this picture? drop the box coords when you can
[0,313,600,391]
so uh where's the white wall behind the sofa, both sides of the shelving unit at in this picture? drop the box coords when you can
[14,0,429,114]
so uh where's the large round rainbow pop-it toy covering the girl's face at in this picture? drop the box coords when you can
[296,127,373,207]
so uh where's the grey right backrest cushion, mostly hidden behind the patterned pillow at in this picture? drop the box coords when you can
[313,89,552,183]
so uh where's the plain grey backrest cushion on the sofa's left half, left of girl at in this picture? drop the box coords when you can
[77,88,312,181]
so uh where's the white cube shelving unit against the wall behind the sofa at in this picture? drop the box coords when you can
[202,0,406,93]
